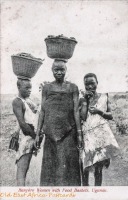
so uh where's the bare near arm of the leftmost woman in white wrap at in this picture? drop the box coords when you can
[12,99,36,138]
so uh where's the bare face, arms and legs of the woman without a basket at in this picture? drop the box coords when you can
[80,77,113,186]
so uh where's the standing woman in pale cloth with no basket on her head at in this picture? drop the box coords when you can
[80,73,119,186]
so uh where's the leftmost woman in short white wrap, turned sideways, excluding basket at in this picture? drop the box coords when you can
[12,78,36,186]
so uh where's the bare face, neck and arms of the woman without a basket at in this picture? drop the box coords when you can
[81,77,113,121]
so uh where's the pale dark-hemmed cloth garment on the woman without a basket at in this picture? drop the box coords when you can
[81,94,119,169]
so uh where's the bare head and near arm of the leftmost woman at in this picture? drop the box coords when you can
[12,80,36,139]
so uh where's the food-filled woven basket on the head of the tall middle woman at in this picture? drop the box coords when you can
[45,36,77,59]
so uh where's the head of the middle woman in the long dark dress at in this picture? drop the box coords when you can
[52,60,67,81]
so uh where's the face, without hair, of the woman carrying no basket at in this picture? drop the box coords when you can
[84,77,98,93]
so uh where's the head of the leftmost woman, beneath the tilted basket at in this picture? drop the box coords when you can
[17,79,32,98]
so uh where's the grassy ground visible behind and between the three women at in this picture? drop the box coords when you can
[0,93,128,186]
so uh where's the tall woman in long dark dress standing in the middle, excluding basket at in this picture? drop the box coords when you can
[35,60,82,186]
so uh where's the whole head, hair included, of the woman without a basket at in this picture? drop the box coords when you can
[84,73,98,93]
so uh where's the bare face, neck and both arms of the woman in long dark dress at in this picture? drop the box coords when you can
[35,64,82,148]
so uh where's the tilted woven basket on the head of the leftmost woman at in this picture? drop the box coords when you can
[11,53,43,78]
